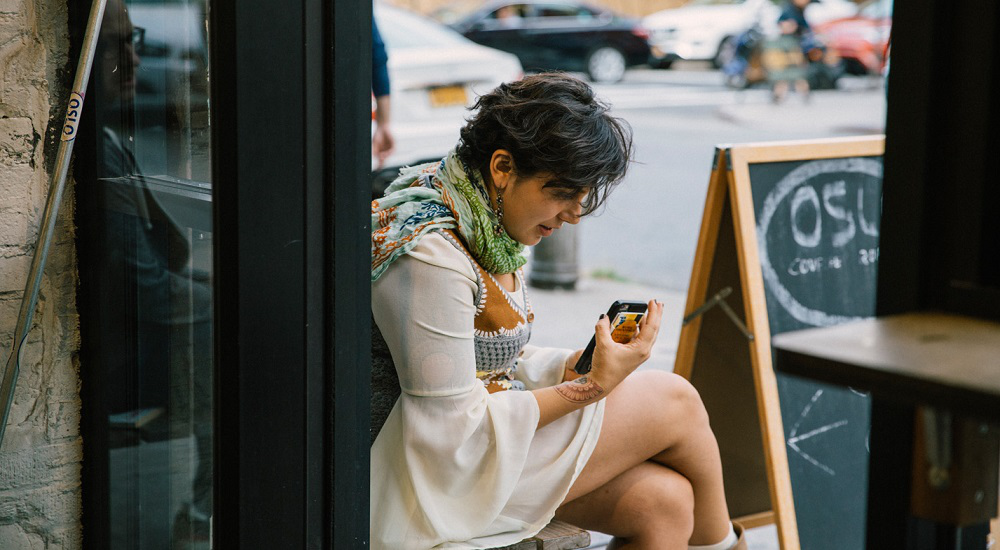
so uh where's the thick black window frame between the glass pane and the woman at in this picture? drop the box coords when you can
[70,0,372,549]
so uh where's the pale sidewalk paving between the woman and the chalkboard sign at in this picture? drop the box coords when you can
[529,276,778,550]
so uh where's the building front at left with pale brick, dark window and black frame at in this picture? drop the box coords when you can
[0,0,371,550]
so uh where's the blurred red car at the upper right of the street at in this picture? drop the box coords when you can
[815,0,892,75]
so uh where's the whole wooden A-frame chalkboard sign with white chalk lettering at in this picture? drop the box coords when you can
[674,136,885,550]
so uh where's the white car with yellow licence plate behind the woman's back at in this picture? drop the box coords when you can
[372,5,524,196]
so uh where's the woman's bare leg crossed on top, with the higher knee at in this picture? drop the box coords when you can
[564,371,729,545]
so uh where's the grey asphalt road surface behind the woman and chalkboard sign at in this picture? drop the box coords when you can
[579,70,885,291]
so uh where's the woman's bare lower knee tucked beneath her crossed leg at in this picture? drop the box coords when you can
[556,461,694,550]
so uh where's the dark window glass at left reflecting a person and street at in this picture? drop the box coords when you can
[88,0,213,550]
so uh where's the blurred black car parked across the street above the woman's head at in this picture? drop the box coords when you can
[433,0,649,82]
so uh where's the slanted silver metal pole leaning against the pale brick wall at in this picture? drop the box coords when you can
[0,0,107,446]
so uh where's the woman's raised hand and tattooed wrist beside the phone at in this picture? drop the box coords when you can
[588,300,663,395]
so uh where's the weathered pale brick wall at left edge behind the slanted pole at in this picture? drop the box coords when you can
[0,0,82,550]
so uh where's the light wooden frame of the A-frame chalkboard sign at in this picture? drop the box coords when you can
[674,135,885,550]
